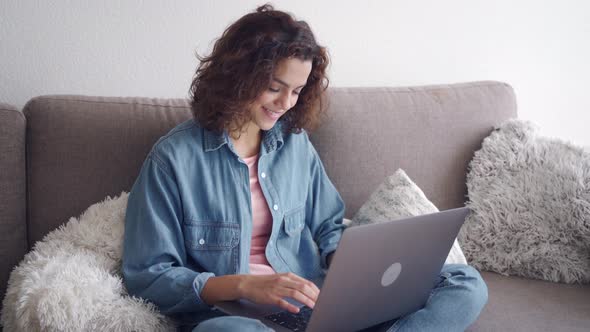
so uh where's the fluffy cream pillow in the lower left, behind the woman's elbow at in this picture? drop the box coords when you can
[2,193,175,332]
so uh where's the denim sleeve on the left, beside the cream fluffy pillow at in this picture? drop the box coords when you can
[122,151,214,314]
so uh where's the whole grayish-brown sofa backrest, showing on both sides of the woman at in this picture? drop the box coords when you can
[24,82,516,246]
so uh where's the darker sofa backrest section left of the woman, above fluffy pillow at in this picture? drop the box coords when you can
[23,95,191,247]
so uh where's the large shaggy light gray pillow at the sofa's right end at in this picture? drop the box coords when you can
[459,119,590,283]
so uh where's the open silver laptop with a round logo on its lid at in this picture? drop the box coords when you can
[216,208,469,332]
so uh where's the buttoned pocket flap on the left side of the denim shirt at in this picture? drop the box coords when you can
[185,222,240,250]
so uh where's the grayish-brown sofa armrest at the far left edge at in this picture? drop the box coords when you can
[0,103,28,308]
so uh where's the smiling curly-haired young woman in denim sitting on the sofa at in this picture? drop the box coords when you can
[123,5,487,331]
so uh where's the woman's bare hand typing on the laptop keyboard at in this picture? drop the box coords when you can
[238,272,320,313]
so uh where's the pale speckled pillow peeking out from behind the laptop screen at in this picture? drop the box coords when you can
[350,169,467,264]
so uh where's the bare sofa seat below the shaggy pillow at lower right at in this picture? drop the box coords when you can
[468,272,590,332]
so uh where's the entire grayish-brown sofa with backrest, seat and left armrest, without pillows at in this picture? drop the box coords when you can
[0,82,590,331]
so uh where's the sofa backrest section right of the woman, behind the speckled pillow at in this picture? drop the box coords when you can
[312,82,516,218]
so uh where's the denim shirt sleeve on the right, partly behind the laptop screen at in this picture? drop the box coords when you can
[306,143,346,268]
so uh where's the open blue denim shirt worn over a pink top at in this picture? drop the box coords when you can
[122,120,345,314]
